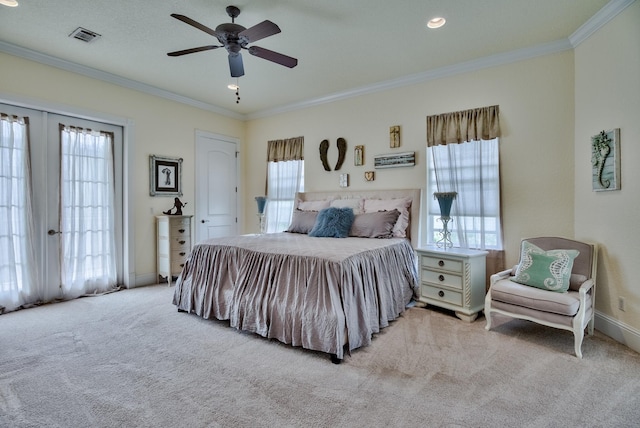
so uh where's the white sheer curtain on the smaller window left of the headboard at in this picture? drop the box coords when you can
[265,160,304,233]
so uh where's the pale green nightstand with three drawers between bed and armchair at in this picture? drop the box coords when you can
[416,247,487,322]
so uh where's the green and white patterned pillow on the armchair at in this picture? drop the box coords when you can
[511,241,580,293]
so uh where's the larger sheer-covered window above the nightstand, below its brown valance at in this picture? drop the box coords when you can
[427,138,502,250]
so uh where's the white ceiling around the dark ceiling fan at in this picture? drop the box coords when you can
[0,0,629,118]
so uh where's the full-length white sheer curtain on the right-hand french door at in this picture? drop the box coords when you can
[60,125,116,298]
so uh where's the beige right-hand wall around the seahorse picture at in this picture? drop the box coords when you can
[575,2,640,338]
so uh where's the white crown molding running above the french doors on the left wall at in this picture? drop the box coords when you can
[0,41,246,120]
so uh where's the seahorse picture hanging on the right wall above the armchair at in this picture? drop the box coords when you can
[591,128,620,192]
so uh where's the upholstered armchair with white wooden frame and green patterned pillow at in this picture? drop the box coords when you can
[484,237,597,358]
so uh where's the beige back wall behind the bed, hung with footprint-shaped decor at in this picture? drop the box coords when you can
[245,52,574,265]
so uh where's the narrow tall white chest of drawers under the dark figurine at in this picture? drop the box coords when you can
[156,215,193,285]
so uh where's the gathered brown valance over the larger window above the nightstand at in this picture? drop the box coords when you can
[427,105,500,147]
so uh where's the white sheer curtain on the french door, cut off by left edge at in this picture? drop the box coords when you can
[0,115,38,313]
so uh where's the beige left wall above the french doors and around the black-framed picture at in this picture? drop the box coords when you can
[0,53,244,283]
